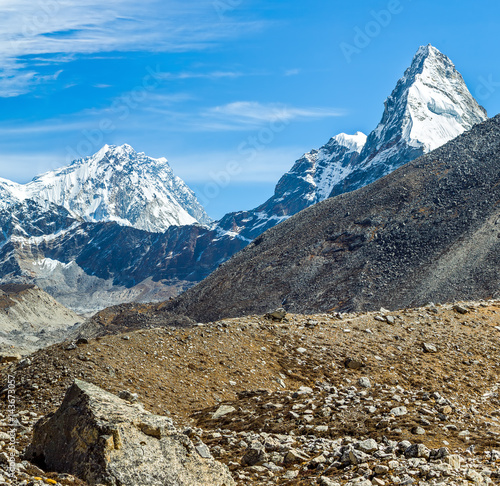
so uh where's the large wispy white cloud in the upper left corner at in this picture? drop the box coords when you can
[0,0,263,97]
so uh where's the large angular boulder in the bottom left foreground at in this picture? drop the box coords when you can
[26,380,234,486]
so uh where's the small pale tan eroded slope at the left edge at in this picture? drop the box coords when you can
[0,284,84,359]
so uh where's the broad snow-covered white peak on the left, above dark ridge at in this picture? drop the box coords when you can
[0,145,210,232]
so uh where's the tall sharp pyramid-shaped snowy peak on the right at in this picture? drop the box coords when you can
[330,44,488,196]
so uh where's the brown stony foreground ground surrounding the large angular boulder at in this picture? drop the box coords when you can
[0,301,500,486]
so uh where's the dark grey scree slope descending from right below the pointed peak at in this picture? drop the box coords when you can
[167,116,500,321]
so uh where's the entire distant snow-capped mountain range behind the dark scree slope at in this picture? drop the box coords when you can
[0,46,487,312]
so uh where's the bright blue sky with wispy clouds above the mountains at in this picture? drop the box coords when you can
[0,0,500,218]
